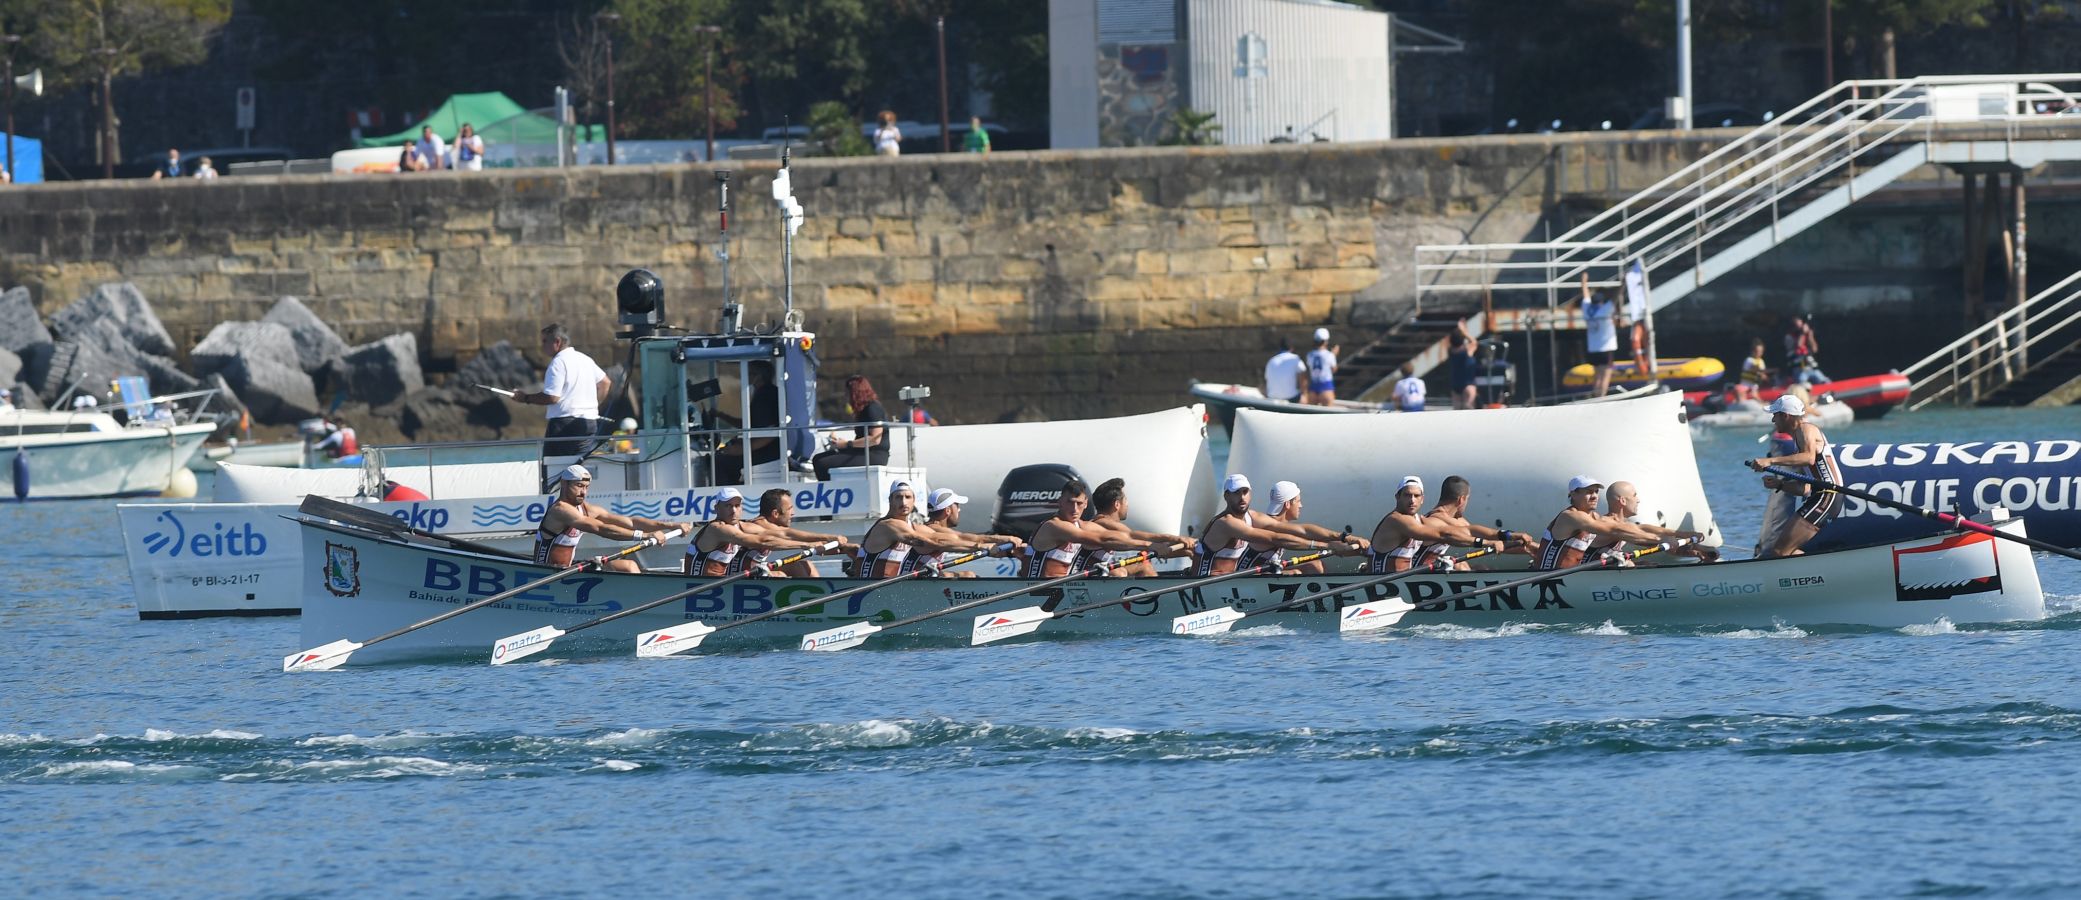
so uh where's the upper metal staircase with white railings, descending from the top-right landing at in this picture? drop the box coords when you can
[1415,75,2081,373]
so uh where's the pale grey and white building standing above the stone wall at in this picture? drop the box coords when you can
[1049,0,1394,150]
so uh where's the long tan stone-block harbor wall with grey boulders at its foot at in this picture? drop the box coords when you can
[0,133,2071,427]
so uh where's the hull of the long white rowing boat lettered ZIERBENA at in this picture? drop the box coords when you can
[298,517,2046,663]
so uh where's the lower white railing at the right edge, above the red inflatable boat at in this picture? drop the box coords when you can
[1900,273,2081,410]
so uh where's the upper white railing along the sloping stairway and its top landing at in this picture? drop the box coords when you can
[1415,75,2081,306]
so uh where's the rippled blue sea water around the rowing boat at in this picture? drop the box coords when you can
[0,410,2081,898]
